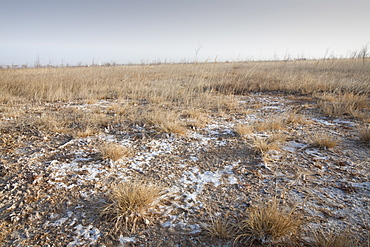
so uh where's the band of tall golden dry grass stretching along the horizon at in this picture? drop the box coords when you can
[0,58,370,108]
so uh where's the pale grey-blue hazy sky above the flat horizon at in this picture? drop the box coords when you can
[0,0,370,66]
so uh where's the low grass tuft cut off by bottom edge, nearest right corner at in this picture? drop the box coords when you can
[307,230,360,247]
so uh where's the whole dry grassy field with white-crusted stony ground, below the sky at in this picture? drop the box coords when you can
[0,58,370,247]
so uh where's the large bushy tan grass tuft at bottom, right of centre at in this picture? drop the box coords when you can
[236,199,302,245]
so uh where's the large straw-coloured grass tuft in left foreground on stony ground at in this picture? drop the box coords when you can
[100,181,164,233]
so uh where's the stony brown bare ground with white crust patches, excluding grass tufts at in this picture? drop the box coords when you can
[0,94,370,246]
